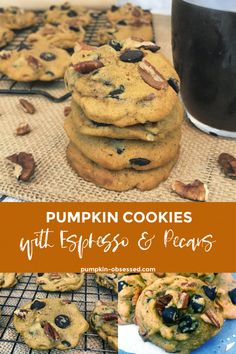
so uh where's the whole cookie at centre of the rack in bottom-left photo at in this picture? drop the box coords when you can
[13,298,89,350]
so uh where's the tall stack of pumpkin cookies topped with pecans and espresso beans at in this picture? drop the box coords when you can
[65,39,183,191]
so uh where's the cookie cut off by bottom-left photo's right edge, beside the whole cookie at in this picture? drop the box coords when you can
[90,301,118,350]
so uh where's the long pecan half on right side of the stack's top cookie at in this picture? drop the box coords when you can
[138,59,168,90]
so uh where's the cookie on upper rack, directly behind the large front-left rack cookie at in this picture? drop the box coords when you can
[27,23,85,49]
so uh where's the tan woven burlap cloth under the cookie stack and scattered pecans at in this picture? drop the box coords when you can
[0,83,236,202]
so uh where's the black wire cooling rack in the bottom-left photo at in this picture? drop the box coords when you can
[0,273,117,354]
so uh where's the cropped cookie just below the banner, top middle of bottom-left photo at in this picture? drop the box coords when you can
[36,273,84,292]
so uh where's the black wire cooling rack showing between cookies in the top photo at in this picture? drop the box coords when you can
[0,12,107,103]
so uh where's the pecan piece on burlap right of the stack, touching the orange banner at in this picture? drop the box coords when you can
[172,179,208,202]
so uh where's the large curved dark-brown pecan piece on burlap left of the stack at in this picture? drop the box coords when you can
[7,152,35,182]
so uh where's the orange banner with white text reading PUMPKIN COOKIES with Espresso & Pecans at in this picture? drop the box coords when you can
[0,202,236,272]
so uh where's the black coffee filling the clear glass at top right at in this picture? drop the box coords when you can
[172,0,236,131]
